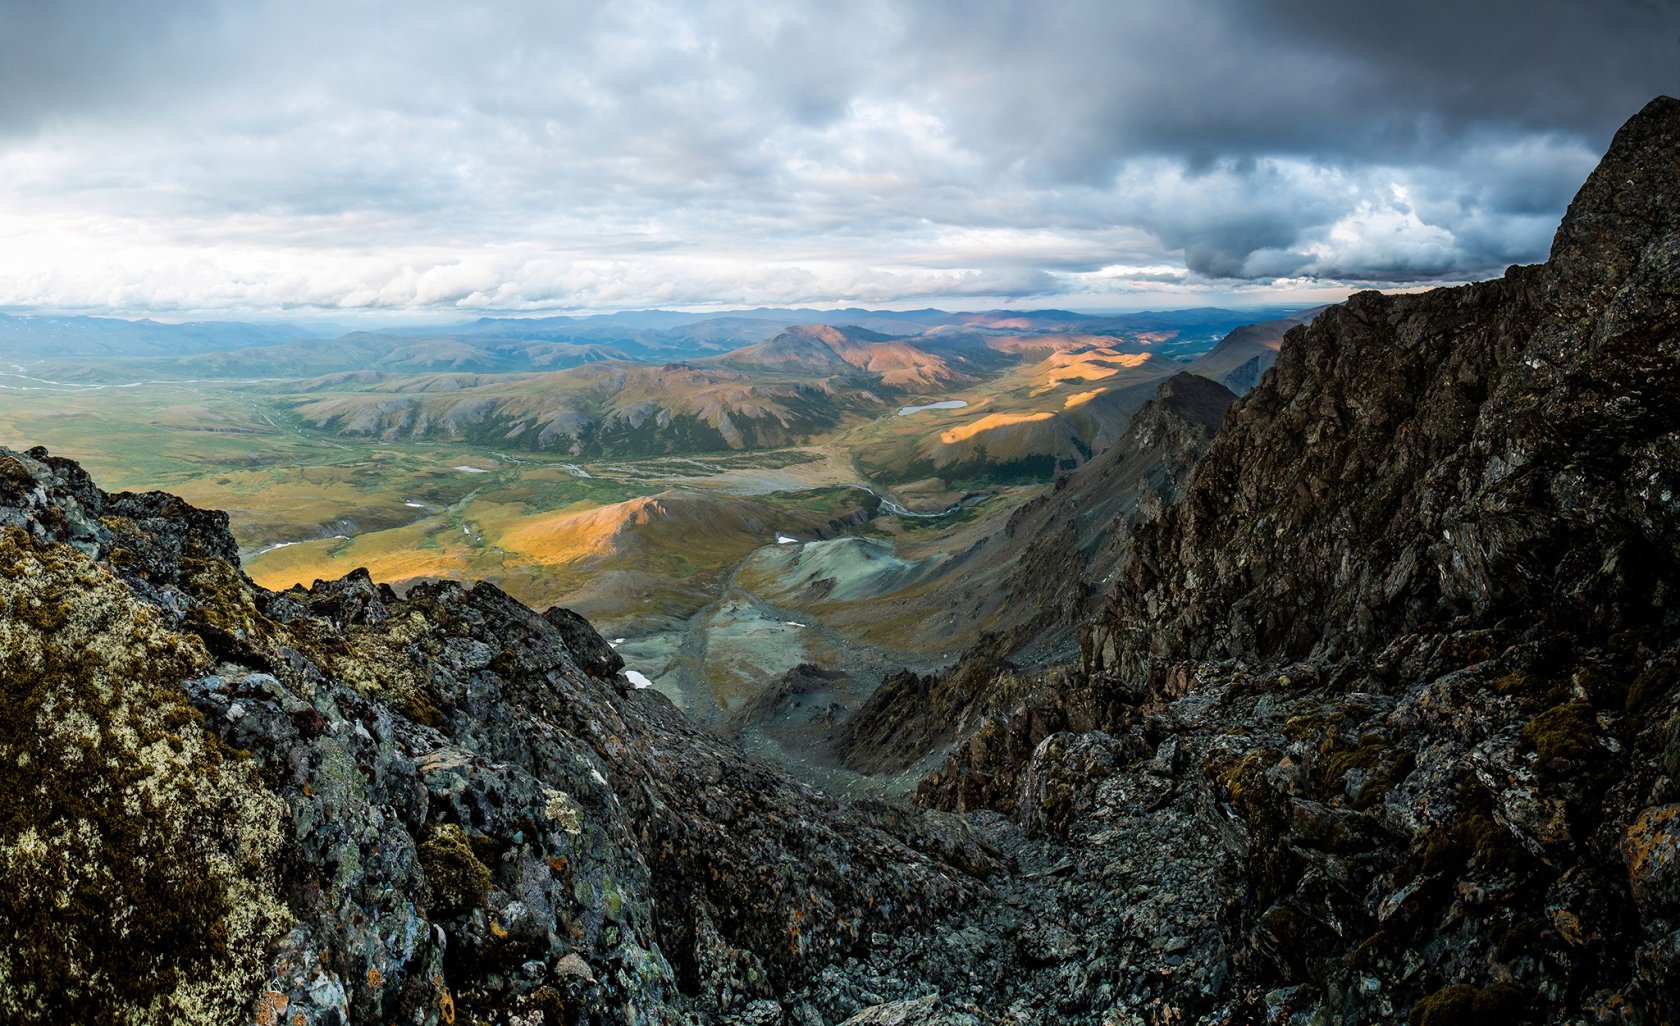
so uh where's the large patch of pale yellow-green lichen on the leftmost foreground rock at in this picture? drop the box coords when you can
[0,529,289,1024]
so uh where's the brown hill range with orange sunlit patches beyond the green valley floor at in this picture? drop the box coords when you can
[268,311,1304,482]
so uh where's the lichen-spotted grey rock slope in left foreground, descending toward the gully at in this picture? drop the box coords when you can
[0,450,991,1024]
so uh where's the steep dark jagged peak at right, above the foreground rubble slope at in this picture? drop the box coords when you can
[1105,99,1680,673]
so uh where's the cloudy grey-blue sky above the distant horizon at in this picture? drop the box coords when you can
[0,0,1680,319]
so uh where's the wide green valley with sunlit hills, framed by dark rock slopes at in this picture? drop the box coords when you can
[0,311,1294,745]
